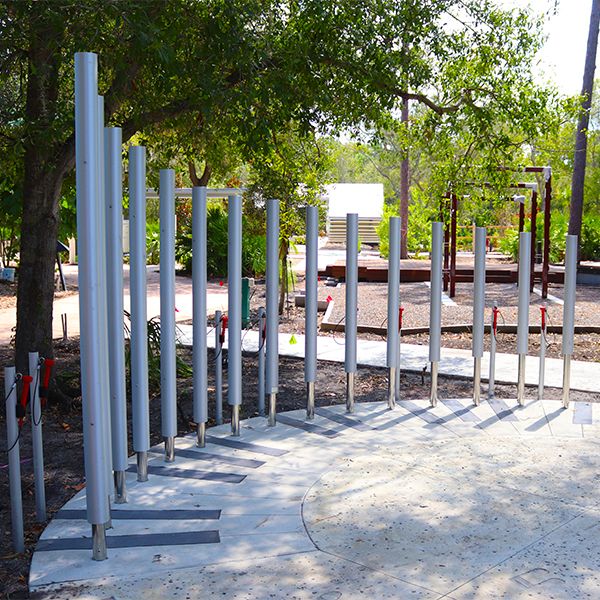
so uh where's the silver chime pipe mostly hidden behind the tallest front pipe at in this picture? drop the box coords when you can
[97,96,113,529]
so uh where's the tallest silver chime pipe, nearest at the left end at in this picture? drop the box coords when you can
[75,52,110,560]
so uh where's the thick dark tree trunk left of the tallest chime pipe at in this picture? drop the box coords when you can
[15,16,65,373]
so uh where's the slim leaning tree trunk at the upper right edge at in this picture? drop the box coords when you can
[569,0,600,236]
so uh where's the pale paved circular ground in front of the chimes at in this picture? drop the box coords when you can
[30,400,600,600]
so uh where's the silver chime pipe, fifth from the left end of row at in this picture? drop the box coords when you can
[159,169,177,462]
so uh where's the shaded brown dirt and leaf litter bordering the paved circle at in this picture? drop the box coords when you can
[0,340,599,599]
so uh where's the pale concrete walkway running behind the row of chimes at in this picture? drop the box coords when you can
[179,325,600,393]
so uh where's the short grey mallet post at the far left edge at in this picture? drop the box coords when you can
[4,367,25,552]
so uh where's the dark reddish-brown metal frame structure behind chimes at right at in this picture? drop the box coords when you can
[440,167,552,298]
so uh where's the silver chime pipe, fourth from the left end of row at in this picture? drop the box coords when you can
[129,146,150,481]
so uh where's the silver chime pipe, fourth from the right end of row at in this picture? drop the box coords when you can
[429,222,444,406]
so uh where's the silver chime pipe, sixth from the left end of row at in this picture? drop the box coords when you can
[192,187,211,448]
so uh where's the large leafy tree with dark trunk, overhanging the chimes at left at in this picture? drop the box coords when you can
[0,0,544,367]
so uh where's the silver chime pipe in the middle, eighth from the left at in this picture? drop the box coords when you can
[267,199,279,427]
